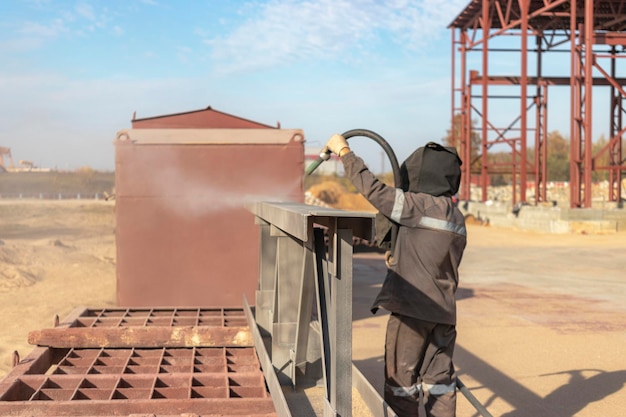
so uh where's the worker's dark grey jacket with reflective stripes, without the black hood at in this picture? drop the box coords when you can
[341,152,466,325]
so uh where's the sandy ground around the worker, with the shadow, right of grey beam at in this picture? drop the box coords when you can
[353,226,626,417]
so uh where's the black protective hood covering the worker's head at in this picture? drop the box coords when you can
[400,142,462,197]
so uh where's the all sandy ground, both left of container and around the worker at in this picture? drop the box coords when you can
[0,200,626,417]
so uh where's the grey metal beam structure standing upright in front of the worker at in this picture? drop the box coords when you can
[252,203,376,417]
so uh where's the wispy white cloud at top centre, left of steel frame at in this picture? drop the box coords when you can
[202,0,466,72]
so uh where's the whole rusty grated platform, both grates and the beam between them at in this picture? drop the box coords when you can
[0,308,277,417]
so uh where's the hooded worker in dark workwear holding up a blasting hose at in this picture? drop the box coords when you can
[325,134,466,417]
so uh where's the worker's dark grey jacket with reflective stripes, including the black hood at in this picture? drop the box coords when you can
[341,142,466,325]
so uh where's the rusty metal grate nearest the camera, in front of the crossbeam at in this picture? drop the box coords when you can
[0,348,268,401]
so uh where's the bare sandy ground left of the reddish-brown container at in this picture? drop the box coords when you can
[0,200,115,377]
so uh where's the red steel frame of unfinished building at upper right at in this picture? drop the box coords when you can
[449,0,626,208]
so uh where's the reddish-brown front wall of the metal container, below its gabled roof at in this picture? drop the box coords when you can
[115,129,304,307]
